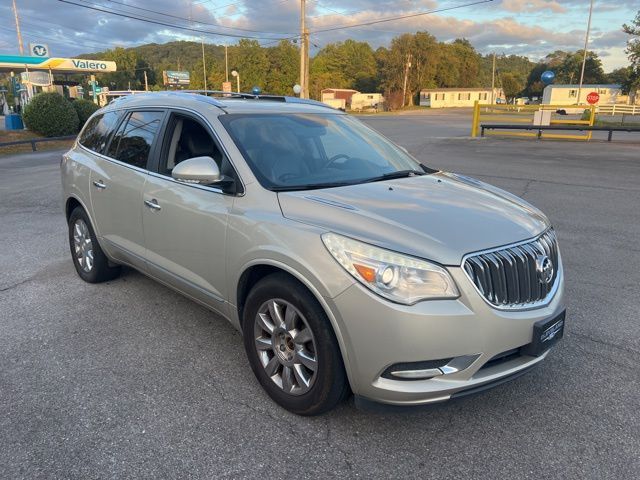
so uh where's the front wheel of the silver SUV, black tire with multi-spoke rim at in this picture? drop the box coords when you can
[242,273,349,415]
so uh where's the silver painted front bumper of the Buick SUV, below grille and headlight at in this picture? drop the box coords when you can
[326,267,564,405]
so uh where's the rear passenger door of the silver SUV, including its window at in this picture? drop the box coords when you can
[90,109,165,269]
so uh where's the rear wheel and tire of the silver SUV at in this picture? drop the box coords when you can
[69,207,120,283]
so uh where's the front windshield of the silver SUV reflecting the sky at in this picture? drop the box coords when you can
[218,113,431,191]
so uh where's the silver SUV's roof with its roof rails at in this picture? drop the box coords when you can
[100,91,342,114]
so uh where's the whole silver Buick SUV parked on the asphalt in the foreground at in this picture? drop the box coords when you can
[61,92,565,415]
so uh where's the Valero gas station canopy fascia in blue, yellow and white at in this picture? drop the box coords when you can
[0,55,116,73]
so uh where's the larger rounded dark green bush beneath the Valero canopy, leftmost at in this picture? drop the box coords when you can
[22,93,79,137]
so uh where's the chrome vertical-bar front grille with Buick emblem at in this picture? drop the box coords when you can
[463,228,559,308]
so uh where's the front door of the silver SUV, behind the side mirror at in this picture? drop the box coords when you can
[142,113,234,313]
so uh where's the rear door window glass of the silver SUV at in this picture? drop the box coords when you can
[108,111,164,168]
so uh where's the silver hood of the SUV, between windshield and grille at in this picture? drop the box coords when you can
[278,172,549,265]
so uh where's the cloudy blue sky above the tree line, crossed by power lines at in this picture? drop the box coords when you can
[0,0,640,71]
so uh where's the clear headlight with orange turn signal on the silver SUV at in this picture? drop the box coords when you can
[322,233,460,305]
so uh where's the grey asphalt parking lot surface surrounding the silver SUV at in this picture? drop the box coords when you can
[0,115,640,480]
